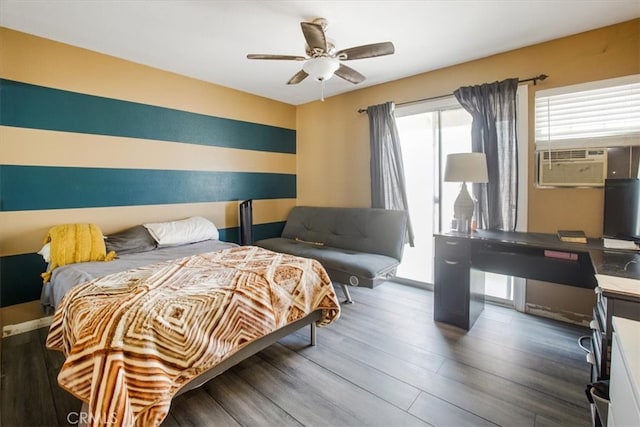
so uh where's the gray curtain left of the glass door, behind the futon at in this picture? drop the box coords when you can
[367,102,414,247]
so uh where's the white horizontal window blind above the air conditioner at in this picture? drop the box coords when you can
[535,75,640,150]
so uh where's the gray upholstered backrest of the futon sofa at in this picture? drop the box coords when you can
[282,206,407,260]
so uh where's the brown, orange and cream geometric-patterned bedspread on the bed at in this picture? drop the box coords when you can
[47,246,340,426]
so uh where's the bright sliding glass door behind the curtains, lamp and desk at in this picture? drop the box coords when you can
[395,94,527,305]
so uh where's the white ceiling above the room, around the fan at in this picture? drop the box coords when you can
[0,0,640,105]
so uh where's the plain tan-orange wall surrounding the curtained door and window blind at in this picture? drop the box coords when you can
[297,19,640,236]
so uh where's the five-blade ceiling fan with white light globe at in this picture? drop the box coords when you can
[247,18,395,95]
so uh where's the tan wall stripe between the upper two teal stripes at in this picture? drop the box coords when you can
[0,126,296,174]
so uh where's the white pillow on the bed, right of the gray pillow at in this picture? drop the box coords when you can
[142,216,220,246]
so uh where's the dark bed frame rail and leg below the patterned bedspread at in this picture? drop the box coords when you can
[78,310,322,427]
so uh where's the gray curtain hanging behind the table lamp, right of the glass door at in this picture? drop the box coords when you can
[453,79,518,231]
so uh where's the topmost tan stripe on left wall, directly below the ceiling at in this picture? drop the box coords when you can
[0,27,296,129]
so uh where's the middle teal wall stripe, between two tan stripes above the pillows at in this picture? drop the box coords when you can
[0,165,296,211]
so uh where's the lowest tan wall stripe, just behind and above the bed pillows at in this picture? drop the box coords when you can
[0,199,296,256]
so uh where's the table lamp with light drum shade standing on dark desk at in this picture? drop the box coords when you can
[444,153,488,233]
